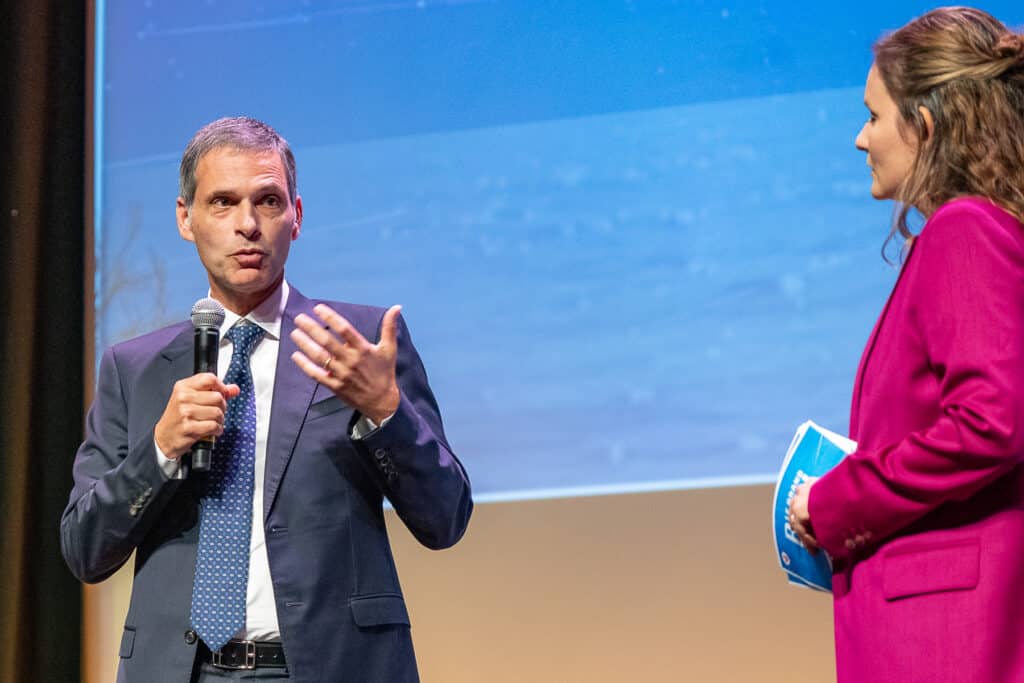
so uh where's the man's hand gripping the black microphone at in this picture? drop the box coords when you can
[153,373,239,460]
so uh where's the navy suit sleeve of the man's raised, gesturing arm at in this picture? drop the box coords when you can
[354,315,473,550]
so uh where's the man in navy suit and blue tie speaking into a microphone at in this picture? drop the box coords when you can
[60,118,472,683]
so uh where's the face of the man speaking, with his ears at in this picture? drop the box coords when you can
[177,147,302,315]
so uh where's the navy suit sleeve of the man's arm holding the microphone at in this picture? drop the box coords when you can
[60,348,181,583]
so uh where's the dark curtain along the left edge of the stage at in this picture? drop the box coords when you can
[0,0,87,683]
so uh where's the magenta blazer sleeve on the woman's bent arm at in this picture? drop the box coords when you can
[809,203,1024,557]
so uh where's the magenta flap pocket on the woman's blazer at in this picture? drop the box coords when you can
[882,539,981,600]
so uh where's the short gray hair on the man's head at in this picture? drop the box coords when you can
[178,116,296,208]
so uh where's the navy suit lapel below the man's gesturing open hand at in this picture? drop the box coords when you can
[263,287,317,521]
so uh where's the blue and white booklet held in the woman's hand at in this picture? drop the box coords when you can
[772,421,857,592]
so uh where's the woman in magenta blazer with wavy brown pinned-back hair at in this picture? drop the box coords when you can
[791,7,1024,683]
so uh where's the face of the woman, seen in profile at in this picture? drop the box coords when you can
[856,66,918,200]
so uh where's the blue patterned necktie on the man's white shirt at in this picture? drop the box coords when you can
[191,321,263,650]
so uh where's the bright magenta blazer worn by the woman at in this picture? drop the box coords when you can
[810,198,1024,683]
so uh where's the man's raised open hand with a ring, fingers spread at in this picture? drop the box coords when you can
[292,304,401,424]
